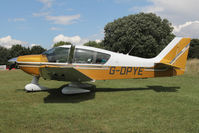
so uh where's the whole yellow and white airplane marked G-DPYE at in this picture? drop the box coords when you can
[9,37,191,94]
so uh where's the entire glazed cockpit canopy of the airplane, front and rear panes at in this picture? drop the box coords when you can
[42,46,110,64]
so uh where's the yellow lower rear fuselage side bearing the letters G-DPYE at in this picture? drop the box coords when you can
[76,67,184,80]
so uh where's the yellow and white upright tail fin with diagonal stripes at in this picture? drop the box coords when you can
[155,37,191,70]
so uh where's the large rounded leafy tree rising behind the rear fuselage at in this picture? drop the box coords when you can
[104,13,175,58]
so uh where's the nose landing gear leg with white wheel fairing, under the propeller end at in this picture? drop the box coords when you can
[25,76,48,92]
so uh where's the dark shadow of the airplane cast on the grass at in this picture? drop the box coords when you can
[44,86,180,103]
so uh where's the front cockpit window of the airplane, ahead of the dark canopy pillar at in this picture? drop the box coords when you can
[43,47,69,63]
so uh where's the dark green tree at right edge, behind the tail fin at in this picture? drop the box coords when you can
[188,39,199,58]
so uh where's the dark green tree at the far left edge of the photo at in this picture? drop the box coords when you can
[0,46,10,65]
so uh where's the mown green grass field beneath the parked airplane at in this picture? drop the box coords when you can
[0,60,199,133]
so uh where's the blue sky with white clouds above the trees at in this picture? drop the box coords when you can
[0,0,199,49]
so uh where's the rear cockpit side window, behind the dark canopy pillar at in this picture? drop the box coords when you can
[73,48,110,64]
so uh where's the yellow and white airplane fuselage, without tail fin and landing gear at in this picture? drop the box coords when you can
[17,40,188,82]
